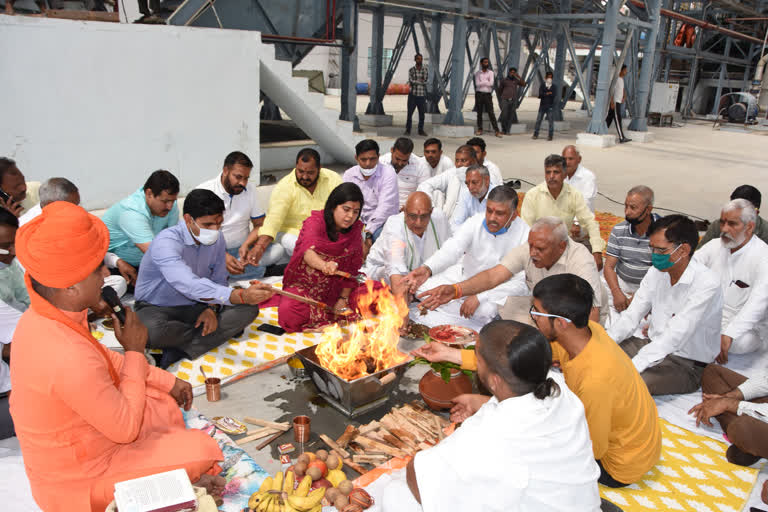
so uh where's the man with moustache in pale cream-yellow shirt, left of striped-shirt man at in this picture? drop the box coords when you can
[520,155,605,270]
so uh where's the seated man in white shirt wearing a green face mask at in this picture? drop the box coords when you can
[608,215,723,395]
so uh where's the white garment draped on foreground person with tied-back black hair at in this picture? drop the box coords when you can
[414,372,600,512]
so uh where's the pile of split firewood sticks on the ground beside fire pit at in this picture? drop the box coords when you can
[320,402,454,474]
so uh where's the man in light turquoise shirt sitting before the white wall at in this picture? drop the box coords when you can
[101,170,179,268]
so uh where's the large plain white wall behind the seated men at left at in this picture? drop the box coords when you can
[0,15,264,208]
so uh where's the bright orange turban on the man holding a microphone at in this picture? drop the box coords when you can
[16,201,109,288]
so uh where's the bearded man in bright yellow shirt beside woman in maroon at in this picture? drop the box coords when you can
[247,148,342,266]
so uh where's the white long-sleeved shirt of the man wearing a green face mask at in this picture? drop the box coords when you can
[608,260,723,373]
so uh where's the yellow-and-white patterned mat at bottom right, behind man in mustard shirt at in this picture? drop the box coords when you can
[600,420,758,512]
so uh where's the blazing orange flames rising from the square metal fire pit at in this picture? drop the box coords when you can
[315,281,408,381]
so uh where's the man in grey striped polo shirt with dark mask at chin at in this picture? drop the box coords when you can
[603,185,658,327]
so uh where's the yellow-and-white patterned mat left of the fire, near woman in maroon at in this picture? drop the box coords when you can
[168,307,320,395]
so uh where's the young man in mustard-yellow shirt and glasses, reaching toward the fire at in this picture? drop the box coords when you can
[414,274,661,487]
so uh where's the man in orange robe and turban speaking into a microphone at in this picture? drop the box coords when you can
[10,202,223,512]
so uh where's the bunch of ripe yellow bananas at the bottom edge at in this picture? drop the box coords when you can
[248,471,325,512]
